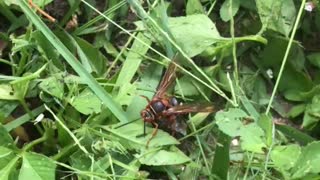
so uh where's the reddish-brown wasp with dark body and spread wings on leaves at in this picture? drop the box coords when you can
[140,55,215,147]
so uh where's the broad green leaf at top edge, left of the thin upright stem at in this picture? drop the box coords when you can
[256,0,296,36]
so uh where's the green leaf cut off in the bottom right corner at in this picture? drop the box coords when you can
[291,141,320,179]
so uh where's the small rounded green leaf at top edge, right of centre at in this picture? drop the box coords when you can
[220,0,240,22]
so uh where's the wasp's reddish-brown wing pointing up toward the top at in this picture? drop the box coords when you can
[154,55,177,98]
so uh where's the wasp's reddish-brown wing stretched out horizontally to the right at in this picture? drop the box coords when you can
[163,104,216,116]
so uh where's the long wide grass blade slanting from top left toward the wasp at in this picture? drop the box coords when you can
[17,1,128,122]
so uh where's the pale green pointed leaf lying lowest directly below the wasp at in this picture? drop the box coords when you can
[135,146,191,166]
